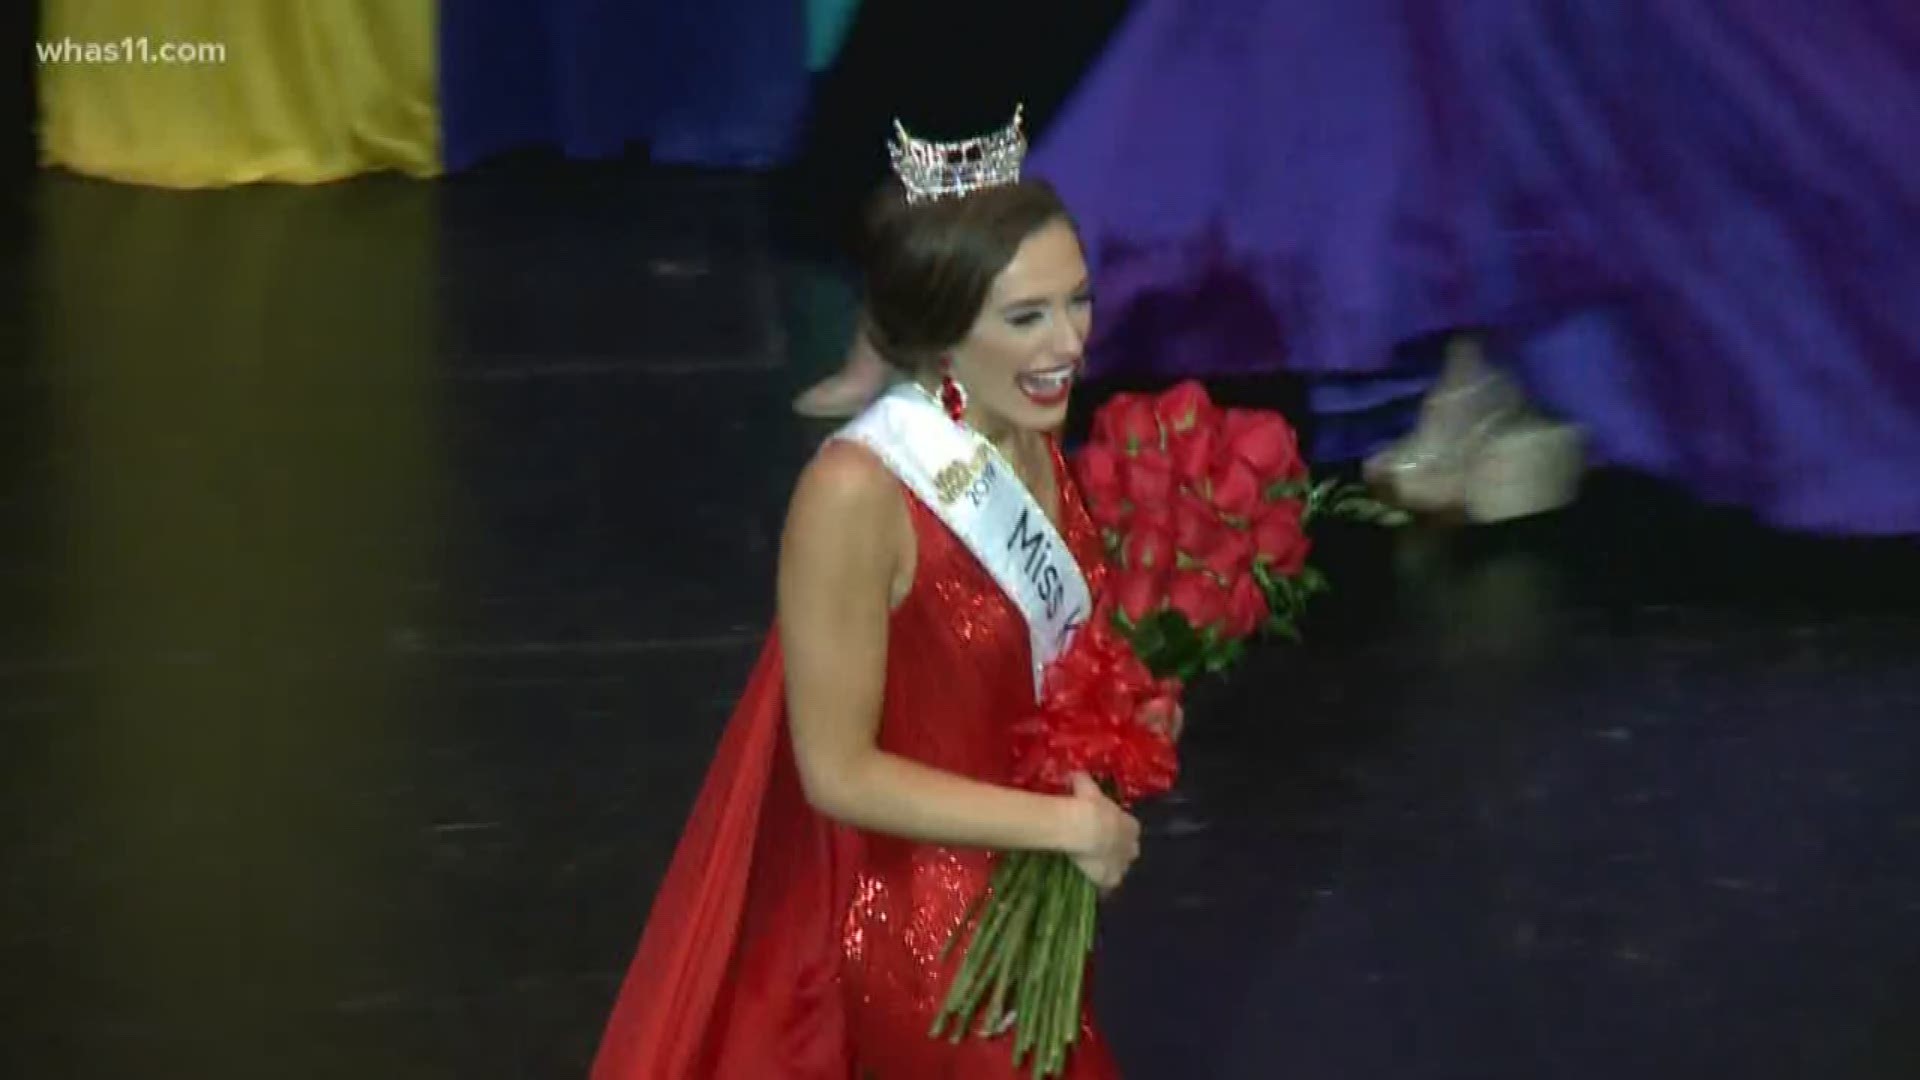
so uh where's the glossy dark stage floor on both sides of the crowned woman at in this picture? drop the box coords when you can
[0,165,1920,1080]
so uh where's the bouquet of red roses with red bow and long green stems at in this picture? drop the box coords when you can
[933,382,1390,1080]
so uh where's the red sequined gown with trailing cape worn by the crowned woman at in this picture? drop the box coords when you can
[593,438,1119,1080]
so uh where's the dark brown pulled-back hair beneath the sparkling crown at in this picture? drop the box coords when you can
[860,181,1071,373]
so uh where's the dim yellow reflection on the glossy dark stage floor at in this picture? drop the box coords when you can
[36,177,441,1053]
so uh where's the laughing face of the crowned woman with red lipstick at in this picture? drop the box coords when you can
[950,219,1092,430]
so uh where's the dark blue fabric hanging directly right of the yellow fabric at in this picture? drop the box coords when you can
[440,0,808,171]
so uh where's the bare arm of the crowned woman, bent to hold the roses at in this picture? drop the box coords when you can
[780,442,1139,884]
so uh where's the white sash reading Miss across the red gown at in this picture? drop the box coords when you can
[837,382,1092,700]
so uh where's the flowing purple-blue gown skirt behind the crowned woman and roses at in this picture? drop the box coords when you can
[1033,0,1920,532]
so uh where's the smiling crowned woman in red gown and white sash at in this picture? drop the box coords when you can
[593,117,1139,1080]
